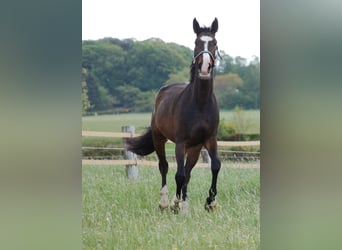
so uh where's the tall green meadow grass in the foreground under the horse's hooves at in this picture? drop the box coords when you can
[82,166,260,249]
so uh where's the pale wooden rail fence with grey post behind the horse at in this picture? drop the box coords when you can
[82,126,260,175]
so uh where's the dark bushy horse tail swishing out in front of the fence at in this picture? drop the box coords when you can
[125,127,154,155]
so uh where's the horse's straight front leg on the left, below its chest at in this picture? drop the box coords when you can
[170,143,185,213]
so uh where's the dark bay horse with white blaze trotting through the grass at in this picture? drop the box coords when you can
[126,18,221,212]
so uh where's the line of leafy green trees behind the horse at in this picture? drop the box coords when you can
[81,38,260,114]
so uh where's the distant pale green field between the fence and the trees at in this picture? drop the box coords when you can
[82,110,260,133]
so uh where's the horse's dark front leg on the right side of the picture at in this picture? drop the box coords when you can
[205,139,221,211]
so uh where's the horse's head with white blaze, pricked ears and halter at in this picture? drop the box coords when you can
[192,18,218,79]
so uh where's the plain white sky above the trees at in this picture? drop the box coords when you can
[82,0,260,59]
